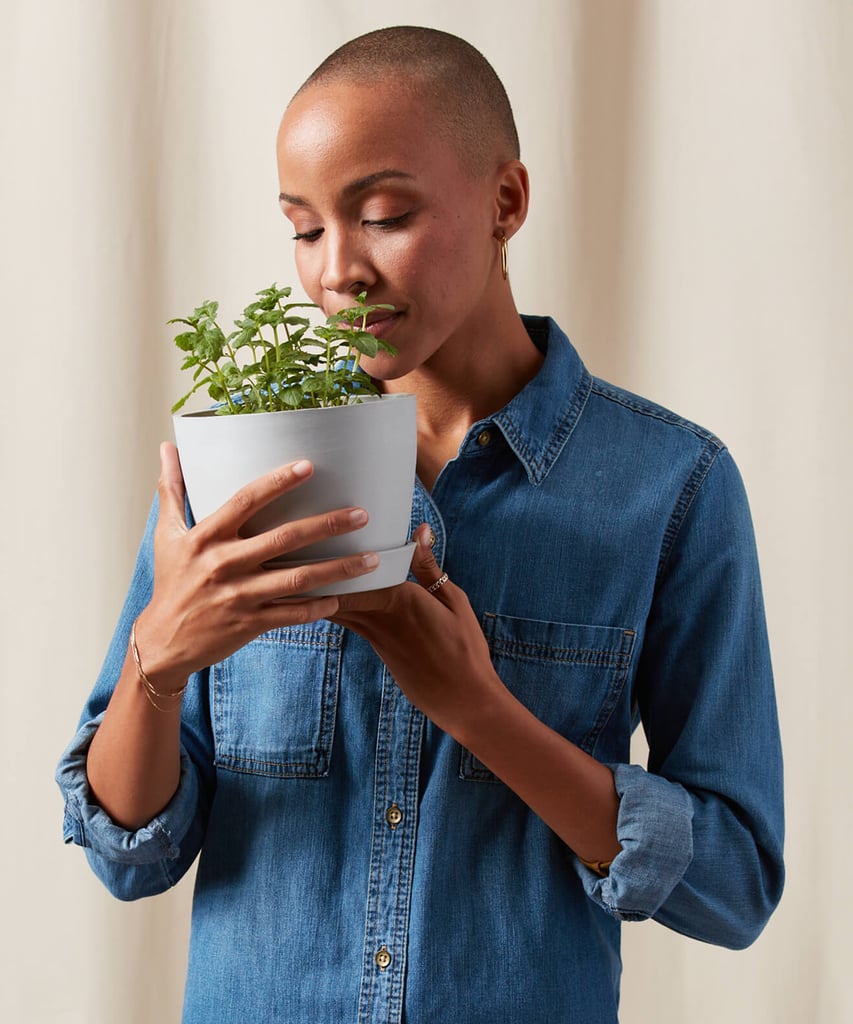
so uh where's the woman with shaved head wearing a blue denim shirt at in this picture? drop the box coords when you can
[59,28,782,1024]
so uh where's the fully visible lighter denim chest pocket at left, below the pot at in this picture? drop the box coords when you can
[211,622,343,778]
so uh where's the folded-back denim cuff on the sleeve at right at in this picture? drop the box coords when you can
[574,764,693,921]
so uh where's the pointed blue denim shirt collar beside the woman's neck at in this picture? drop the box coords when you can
[492,316,592,486]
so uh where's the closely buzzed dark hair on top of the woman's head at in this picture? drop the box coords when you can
[294,26,519,174]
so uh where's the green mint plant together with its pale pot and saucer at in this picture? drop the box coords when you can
[169,285,417,594]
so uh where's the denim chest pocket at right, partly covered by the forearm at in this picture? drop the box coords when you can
[460,613,635,782]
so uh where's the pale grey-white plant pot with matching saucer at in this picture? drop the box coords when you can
[173,394,417,594]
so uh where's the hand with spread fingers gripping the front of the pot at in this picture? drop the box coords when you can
[136,443,378,692]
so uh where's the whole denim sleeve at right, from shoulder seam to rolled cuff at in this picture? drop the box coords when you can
[577,450,784,948]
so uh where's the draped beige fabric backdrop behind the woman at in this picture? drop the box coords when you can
[0,0,853,1024]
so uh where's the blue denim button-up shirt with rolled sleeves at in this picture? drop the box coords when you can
[57,317,783,1024]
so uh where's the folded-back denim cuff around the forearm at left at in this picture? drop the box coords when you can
[56,715,199,864]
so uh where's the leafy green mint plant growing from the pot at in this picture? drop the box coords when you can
[175,285,396,415]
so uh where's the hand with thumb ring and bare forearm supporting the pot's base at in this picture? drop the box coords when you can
[332,526,621,862]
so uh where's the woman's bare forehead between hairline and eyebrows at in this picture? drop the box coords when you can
[278,80,461,182]
